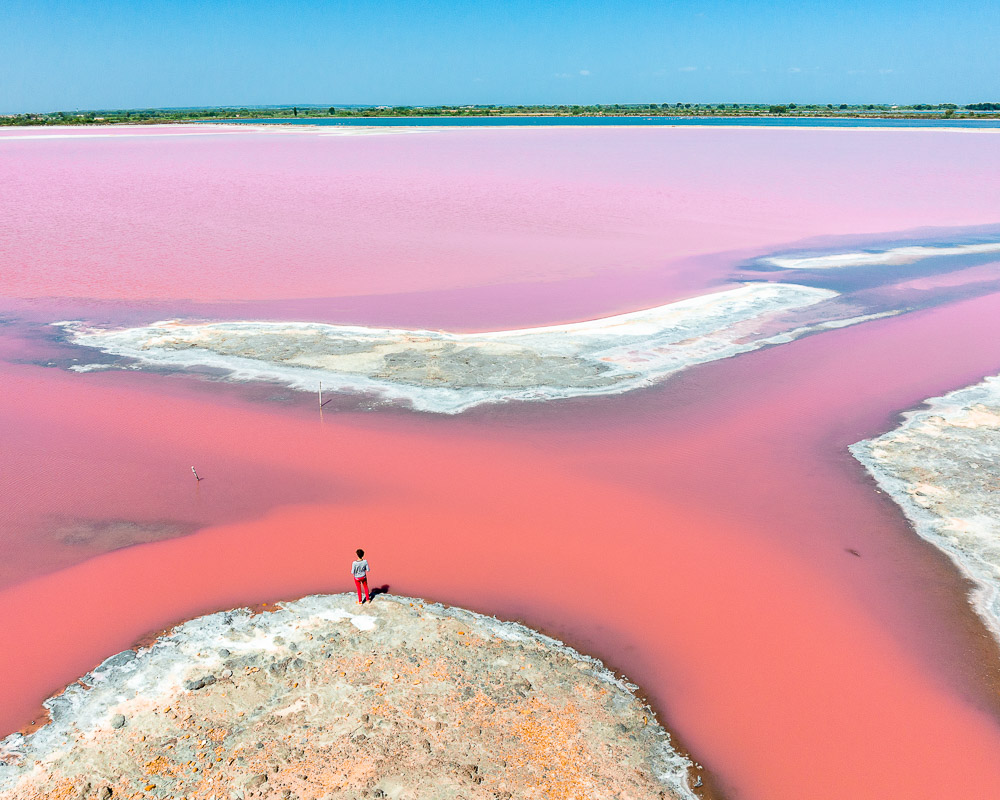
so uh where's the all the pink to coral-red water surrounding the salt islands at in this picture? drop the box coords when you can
[0,129,1000,800]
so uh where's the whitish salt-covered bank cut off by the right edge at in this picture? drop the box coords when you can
[851,376,1000,640]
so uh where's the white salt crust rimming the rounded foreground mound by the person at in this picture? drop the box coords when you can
[0,594,696,800]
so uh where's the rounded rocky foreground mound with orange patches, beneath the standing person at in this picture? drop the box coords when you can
[0,595,694,800]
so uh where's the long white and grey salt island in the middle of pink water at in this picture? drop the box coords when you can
[57,283,871,414]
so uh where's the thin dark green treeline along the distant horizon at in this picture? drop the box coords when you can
[0,103,1000,125]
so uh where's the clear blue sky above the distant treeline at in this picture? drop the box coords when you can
[0,0,1000,113]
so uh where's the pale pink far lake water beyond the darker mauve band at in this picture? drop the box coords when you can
[7,128,997,304]
